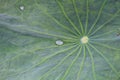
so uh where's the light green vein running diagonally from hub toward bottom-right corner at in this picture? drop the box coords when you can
[89,44,120,77]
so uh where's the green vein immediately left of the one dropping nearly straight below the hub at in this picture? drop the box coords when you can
[61,47,82,80]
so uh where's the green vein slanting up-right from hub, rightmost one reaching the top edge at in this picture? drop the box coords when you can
[88,0,107,34]
